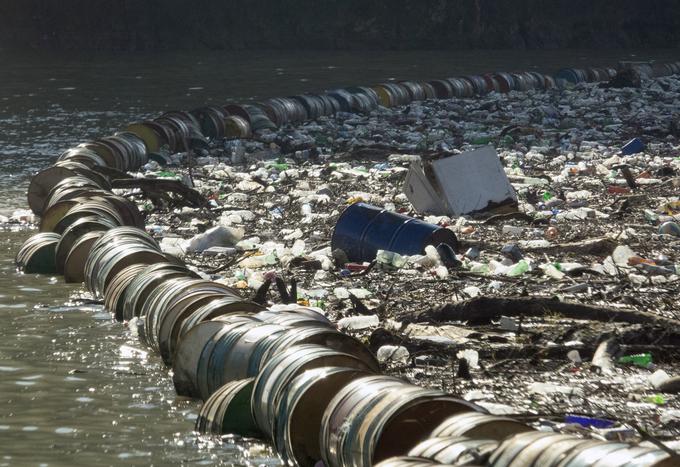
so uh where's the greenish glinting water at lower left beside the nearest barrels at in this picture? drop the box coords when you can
[0,231,276,466]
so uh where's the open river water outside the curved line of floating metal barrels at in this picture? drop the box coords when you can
[0,50,678,467]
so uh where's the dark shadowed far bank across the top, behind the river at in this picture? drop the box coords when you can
[0,0,680,51]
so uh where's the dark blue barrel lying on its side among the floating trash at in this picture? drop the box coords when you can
[331,203,457,262]
